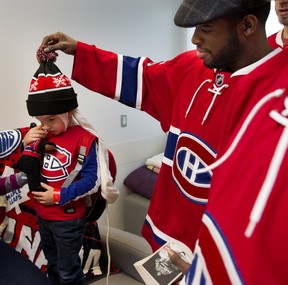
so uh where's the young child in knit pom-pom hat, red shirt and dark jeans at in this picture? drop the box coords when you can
[16,48,119,285]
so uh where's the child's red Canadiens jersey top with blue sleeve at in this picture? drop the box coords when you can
[35,126,97,220]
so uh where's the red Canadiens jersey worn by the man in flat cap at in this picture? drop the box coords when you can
[72,42,274,250]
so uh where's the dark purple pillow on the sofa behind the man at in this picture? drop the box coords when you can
[124,165,158,199]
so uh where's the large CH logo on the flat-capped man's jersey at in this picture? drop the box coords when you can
[172,133,216,204]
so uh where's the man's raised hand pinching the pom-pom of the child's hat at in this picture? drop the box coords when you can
[41,32,77,55]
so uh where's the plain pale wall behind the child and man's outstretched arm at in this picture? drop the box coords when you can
[0,0,182,143]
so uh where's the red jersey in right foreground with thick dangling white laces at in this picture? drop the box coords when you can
[181,46,288,285]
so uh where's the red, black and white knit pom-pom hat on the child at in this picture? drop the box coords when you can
[26,46,78,116]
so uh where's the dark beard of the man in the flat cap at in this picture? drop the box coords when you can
[204,30,243,72]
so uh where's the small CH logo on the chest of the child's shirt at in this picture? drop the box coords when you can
[41,146,71,181]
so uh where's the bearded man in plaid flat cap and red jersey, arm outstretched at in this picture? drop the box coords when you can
[42,0,276,253]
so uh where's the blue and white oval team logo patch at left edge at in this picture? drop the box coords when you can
[0,130,21,158]
